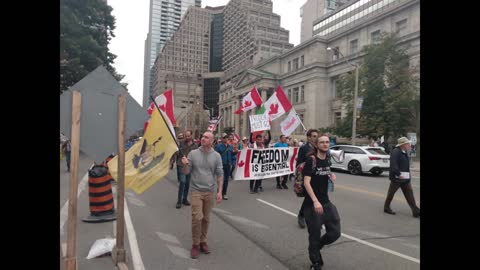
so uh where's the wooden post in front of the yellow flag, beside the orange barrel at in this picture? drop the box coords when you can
[114,95,126,265]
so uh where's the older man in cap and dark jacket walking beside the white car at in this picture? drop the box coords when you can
[383,137,420,218]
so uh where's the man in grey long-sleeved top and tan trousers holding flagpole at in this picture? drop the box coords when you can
[182,131,223,259]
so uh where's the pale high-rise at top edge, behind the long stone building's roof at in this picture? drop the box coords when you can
[300,0,349,42]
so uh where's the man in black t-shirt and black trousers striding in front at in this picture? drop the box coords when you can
[303,136,340,270]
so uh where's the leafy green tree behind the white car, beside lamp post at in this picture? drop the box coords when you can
[335,35,420,140]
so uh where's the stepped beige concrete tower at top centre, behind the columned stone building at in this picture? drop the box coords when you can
[222,0,293,73]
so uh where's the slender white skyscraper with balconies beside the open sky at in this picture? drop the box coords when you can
[143,0,202,107]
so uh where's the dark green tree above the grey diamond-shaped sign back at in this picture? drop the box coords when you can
[60,0,126,93]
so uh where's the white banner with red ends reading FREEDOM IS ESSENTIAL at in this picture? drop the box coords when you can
[234,147,298,180]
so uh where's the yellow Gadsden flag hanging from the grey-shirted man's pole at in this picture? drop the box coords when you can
[108,108,178,194]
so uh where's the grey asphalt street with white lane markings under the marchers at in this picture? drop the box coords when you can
[60,155,420,270]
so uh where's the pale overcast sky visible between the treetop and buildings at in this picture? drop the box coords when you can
[108,0,306,105]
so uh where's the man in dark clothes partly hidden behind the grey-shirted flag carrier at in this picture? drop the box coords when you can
[175,130,198,209]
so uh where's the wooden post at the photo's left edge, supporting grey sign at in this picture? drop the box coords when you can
[65,91,82,270]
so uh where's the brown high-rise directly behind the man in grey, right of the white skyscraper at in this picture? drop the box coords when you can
[152,6,212,138]
